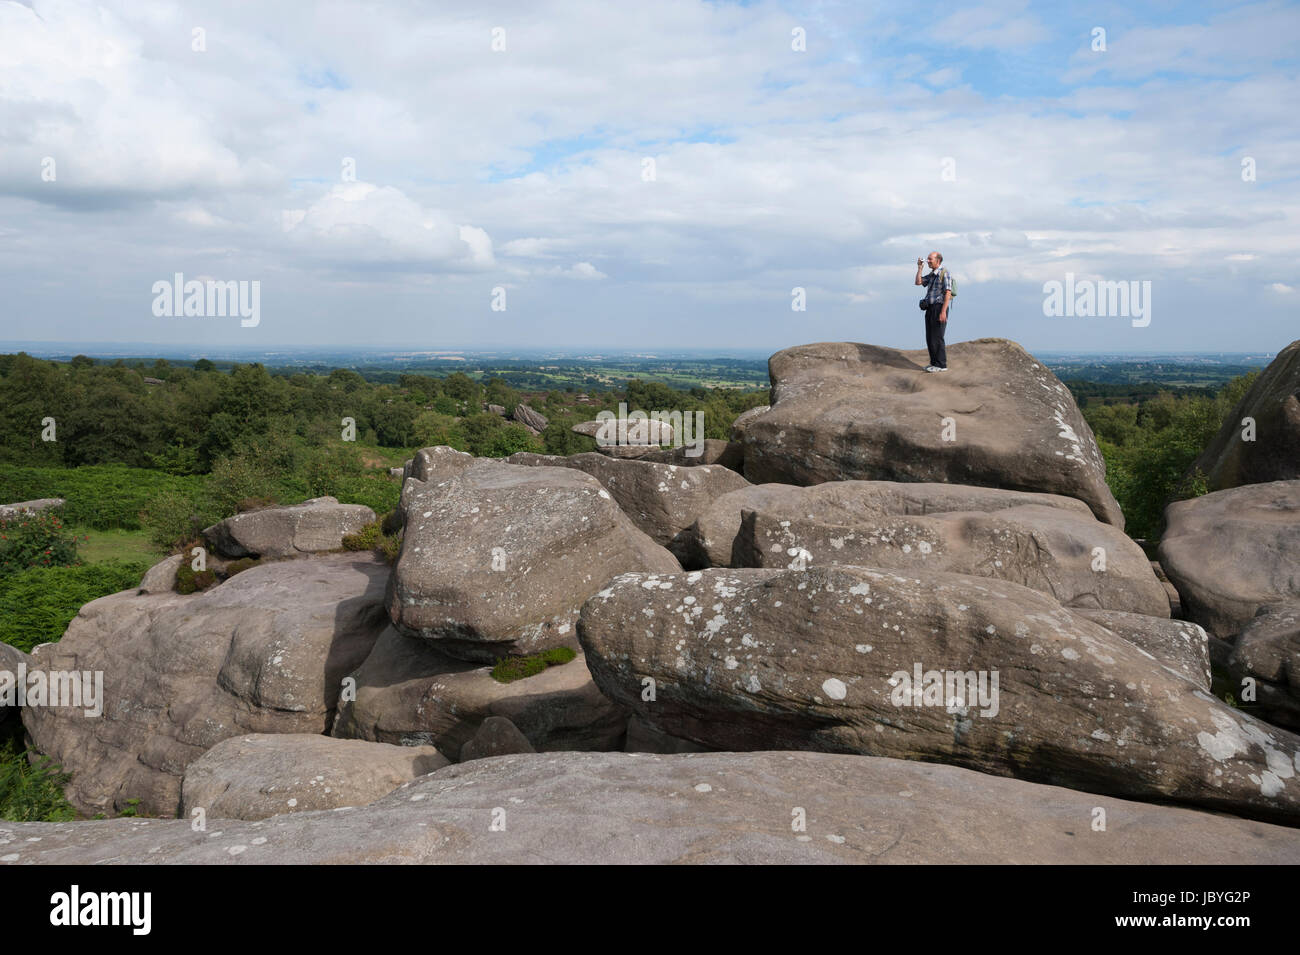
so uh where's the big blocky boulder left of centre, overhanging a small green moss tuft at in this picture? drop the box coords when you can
[387,459,680,663]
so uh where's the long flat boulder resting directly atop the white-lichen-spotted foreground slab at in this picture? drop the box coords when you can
[733,496,1169,617]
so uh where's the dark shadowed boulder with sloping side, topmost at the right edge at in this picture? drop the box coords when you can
[1192,342,1300,491]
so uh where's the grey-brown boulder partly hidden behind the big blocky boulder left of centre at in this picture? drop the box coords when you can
[506,451,749,560]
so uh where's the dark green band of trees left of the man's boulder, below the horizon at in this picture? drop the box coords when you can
[0,353,767,474]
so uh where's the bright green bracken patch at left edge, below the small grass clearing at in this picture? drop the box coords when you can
[0,560,148,654]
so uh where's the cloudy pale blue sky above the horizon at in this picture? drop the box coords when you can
[0,0,1300,353]
